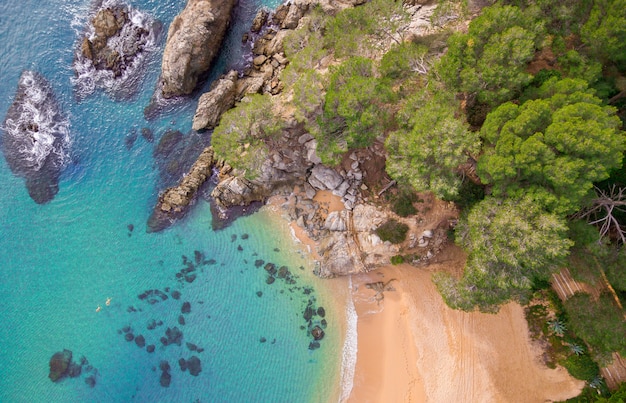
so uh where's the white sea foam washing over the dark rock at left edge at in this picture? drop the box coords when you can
[3,71,70,171]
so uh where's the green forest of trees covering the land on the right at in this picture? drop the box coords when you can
[213,0,626,401]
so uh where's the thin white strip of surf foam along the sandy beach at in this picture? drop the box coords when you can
[339,277,359,402]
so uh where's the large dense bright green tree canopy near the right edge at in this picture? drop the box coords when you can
[478,79,625,214]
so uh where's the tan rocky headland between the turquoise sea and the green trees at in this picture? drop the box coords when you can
[150,0,448,277]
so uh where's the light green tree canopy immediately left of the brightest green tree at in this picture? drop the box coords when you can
[385,91,480,200]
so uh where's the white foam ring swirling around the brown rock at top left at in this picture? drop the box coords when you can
[71,0,158,99]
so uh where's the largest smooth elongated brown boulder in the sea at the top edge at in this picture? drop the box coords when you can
[160,0,235,98]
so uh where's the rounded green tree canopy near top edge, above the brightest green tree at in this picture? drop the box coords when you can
[437,5,544,106]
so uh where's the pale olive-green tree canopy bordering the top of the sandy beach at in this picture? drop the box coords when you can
[435,197,572,312]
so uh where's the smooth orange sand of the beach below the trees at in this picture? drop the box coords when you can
[349,262,583,403]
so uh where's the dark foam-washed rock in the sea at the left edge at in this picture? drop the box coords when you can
[2,70,70,204]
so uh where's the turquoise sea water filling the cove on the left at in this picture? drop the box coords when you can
[0,0,341,402]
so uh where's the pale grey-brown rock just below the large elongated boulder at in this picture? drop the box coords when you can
[192,71,237,130]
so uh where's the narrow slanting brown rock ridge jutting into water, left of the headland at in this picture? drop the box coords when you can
[148,147,216,232]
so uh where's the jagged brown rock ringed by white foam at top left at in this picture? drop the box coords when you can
[74,0,161,98]
